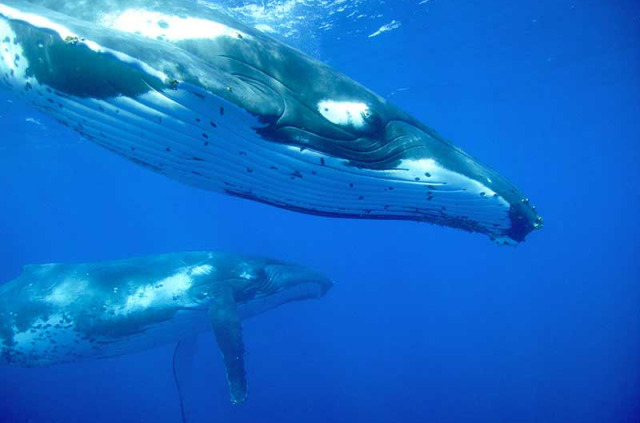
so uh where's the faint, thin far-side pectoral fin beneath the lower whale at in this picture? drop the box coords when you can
[173,336,198,423]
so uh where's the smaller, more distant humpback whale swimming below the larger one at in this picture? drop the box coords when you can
[0,251,332,408]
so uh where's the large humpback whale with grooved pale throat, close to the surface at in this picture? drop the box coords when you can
[0,0,543,244]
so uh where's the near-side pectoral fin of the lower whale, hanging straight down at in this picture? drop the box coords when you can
[209,287,247,404]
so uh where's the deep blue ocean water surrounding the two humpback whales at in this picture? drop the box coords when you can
[0,0,640,423]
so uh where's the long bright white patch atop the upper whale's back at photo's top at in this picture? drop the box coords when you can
[101,9,249,41]
